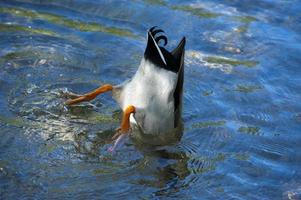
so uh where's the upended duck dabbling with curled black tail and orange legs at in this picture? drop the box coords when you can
[65,26,186,150]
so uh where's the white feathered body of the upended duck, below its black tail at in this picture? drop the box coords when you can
[116,59,178,134]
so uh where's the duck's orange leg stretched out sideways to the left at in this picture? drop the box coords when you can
[65,84,113,105]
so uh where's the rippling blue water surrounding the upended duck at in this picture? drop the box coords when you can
[0,0,301,199]
